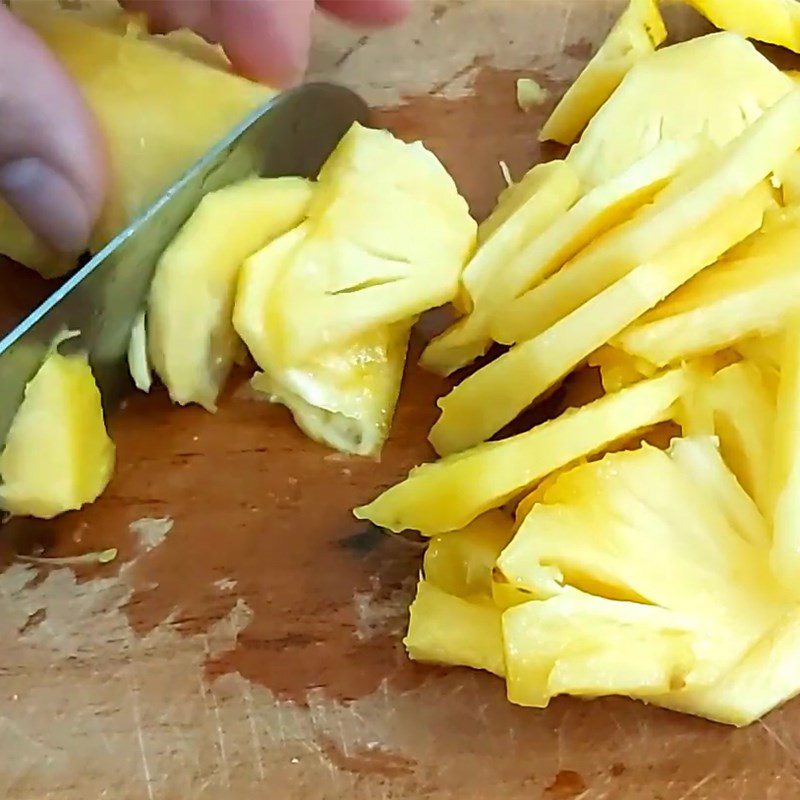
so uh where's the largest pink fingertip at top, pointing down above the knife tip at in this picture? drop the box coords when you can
[211,0,314,86]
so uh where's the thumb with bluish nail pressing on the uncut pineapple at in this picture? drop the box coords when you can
[0,3,106,253]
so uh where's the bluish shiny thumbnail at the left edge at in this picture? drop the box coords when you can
[0,158,91,253]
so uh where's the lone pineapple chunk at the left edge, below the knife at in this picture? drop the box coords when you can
[0,352,114,519]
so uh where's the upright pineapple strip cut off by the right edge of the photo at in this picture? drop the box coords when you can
[771,317,800,595]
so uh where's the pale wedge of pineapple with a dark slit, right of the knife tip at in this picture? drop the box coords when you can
[275,123,477,360]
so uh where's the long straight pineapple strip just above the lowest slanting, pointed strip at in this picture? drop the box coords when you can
[429,185,770,454]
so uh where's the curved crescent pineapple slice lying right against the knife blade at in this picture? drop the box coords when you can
[147,178,312,411]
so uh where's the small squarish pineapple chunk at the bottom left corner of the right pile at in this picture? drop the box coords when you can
[403,580,505,677]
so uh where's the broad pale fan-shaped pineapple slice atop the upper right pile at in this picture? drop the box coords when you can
[568,32,793,186]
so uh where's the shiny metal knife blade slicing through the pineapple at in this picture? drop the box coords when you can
[0,83,368,451]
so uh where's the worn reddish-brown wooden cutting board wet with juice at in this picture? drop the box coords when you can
[0,0,800,800]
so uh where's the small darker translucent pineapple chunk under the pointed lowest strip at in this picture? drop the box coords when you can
[422,511,513,598]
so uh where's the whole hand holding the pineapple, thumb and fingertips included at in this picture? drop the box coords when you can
[0,0,411,253]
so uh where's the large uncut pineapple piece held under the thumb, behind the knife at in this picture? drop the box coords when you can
[0,7,273,275]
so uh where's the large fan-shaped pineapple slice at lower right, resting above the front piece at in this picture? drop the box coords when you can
[497,439,791,688]
